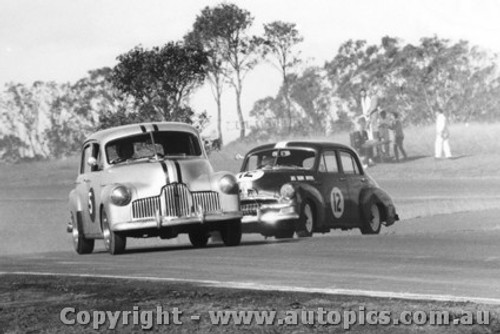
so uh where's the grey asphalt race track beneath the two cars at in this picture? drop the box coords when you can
[0,210,500,304]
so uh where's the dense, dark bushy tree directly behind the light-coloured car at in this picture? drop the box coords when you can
[111,42,208,123]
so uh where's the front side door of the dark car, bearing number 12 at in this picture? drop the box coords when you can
[318,149,349,227]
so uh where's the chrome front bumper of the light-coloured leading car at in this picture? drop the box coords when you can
[111,211,242,231]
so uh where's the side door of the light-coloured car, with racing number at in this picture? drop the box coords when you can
[76,143,100,234]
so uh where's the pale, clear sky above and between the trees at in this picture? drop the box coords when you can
[0,0,500,139]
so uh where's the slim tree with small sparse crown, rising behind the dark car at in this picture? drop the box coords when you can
[262,21,303,133]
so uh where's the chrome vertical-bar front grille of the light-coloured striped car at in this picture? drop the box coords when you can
[132,183,221,219]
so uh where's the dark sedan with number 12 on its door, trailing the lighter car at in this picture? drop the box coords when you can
[237,141,398,238]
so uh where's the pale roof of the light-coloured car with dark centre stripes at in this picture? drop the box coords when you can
[85,122,198,142]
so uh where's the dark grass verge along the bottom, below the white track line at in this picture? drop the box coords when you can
[0,275,500,333]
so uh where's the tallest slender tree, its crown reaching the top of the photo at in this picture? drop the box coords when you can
[195,3,259,138]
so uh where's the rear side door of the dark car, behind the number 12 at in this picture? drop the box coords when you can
[338,150,367,226]
